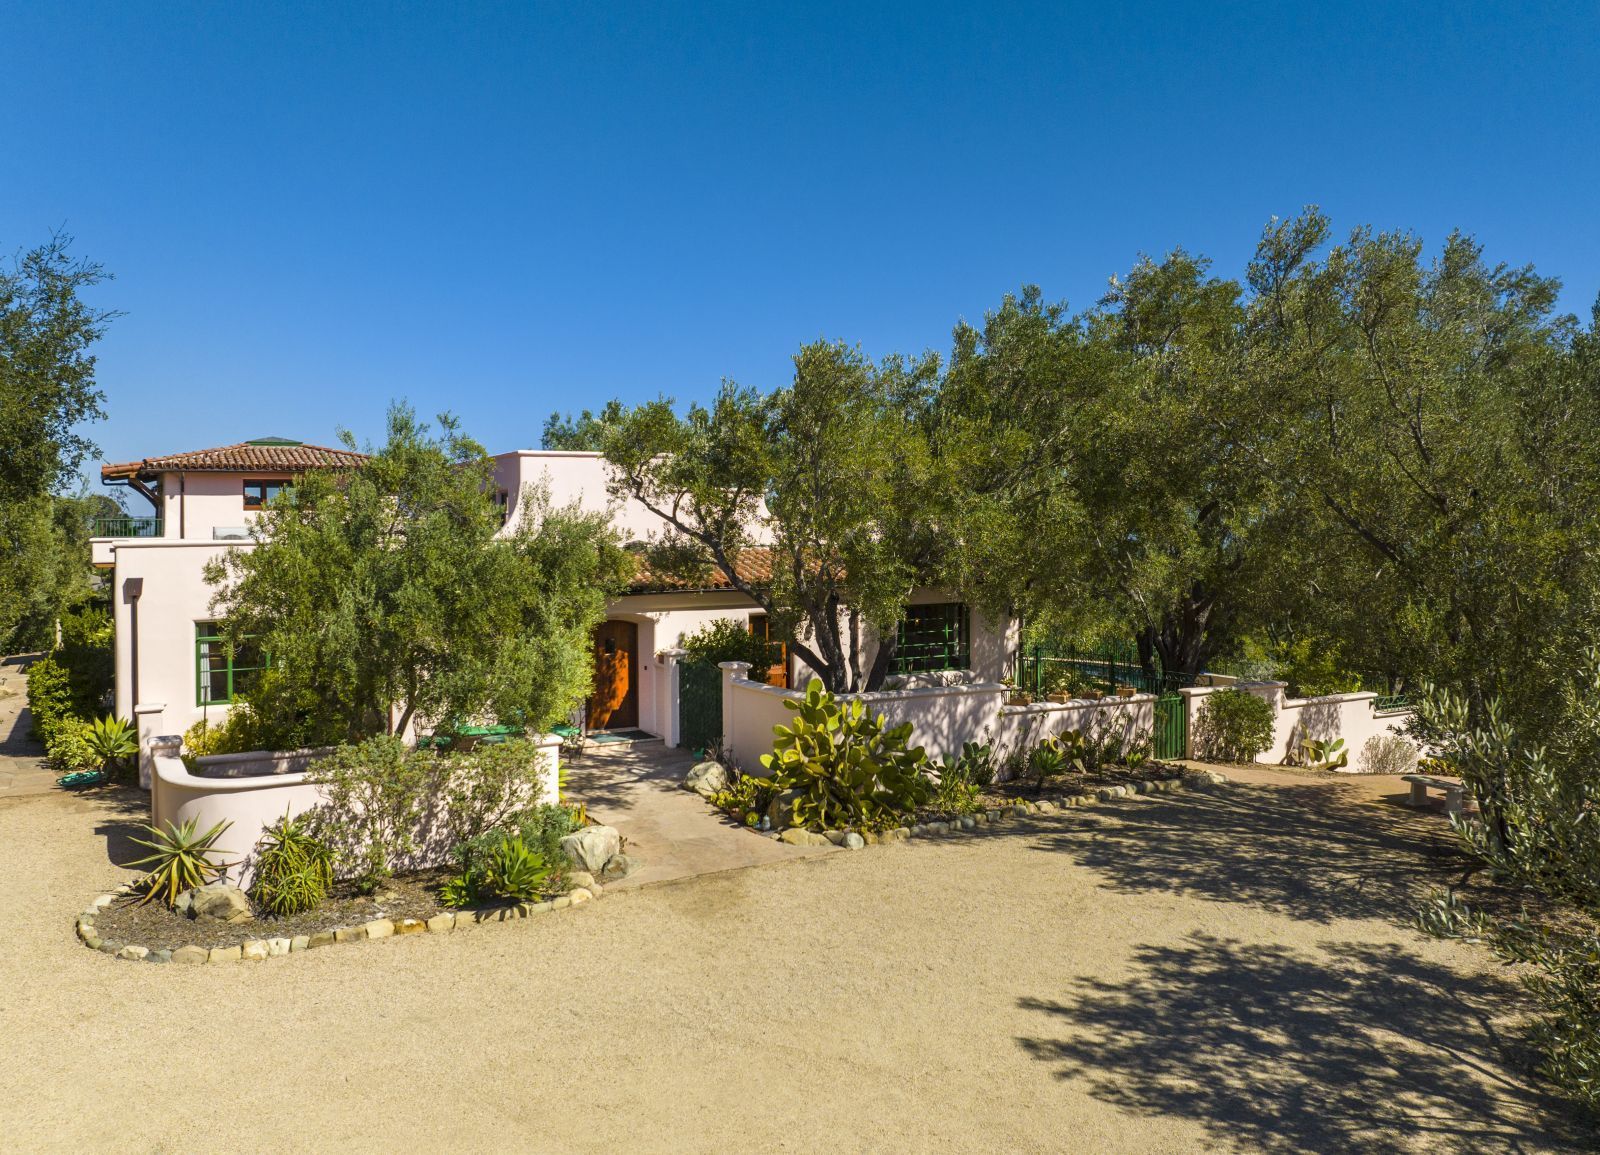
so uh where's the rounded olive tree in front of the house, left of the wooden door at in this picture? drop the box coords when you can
[206,405,629,742]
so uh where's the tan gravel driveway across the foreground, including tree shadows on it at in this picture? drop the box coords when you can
[0,784,1597,1153]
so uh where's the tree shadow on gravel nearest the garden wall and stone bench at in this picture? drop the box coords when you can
[1037,784,1467,923]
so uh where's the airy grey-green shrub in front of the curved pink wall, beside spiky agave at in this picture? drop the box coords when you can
[307,734,450,893]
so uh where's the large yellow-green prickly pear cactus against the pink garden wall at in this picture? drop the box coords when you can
[762,678,933,830]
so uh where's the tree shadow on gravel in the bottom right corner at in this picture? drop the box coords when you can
[1018,934,1600,1152]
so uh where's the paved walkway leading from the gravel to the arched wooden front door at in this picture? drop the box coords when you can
[566,741,835,889]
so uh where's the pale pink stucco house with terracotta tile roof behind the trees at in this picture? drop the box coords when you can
[91,437,1016,741]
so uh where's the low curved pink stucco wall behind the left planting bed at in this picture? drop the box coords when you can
[147,734,562,888]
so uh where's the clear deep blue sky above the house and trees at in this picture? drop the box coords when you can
[0,3,1600,489]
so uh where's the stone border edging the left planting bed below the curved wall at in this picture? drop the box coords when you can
[77,870,605,966]
